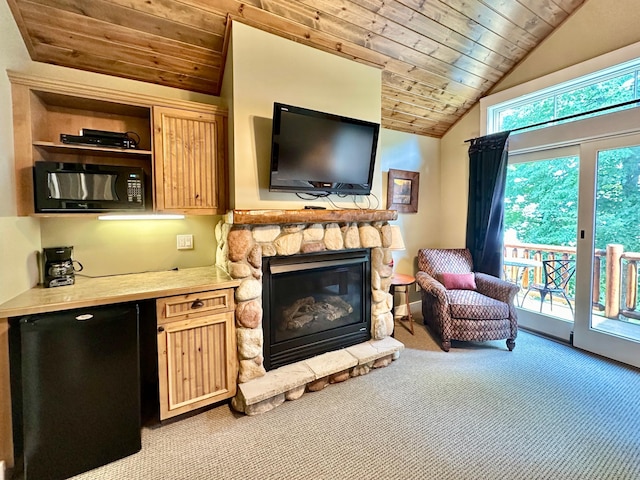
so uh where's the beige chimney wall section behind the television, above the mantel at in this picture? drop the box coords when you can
[225,22,381,209]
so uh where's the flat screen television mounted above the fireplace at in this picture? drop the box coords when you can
[269,103,380,195]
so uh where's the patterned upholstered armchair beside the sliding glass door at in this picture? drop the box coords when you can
[416,249,518,352]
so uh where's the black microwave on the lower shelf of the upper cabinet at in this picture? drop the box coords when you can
[33,162,145,213]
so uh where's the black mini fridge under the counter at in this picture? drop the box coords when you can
[11,304,141,480]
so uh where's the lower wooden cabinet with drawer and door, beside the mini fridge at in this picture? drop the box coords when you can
[156,288,237,420]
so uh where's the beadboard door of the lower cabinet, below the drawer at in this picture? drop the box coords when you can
[158,312,237,420]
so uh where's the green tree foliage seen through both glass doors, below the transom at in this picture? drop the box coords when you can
[504,151,640,252]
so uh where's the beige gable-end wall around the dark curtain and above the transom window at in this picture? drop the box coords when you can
[440,0,640,247]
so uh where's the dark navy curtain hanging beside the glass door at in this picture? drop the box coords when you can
[467,132,510,277]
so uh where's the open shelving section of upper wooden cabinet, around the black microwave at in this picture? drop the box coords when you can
[9,74,152,215]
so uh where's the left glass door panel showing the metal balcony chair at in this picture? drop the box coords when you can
[504,147,580,341]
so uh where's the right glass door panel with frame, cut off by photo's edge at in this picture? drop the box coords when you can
[574,135,640,366]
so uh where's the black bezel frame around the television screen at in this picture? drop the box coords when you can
[269,102,380,195]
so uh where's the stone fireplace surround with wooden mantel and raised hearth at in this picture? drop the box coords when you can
[216,209,403,414]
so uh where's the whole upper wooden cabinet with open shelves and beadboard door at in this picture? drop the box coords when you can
[9,72,227,216]
